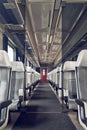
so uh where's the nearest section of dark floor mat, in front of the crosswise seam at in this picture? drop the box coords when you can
[13,113,76,130]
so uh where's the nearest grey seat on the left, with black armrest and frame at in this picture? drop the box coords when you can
[0,50,11,129]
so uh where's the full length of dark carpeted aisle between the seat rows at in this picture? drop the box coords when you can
[12,83,76,130]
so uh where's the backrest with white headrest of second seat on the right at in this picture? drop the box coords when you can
[63,61,77,99]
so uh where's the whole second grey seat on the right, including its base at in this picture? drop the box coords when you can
[63,61,77,109]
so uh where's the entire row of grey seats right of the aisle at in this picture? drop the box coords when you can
[48,50,87,130]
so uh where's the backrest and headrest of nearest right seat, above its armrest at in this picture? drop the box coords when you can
[76,50,87,101]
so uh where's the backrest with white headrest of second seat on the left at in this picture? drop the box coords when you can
[10,61,24,100]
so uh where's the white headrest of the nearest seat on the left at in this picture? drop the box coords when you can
[0,50,11,68]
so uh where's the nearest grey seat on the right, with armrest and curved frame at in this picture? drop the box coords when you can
[76,50,87,130]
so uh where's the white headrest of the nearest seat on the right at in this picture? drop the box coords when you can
[76,50,87,67]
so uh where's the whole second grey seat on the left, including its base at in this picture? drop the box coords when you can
[10,61,24,110]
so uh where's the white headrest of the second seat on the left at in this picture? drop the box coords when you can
[11,61,24,72]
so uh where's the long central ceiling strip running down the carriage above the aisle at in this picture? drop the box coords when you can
[28,0,54,65]
